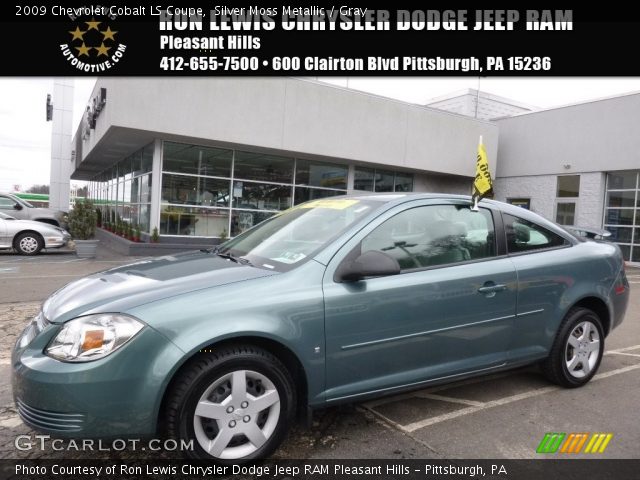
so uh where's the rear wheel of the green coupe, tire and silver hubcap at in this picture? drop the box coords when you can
[542,307,604,388]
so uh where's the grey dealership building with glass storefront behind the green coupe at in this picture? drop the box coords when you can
[71,77,640,262]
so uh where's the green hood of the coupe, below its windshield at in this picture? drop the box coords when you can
[43,251,277,323]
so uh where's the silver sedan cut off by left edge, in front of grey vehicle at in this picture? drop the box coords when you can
[0,212,71,255]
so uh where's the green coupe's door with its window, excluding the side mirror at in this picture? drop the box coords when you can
[323,200,517,401]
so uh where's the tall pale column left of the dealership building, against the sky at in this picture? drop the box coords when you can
[49,77,75,212]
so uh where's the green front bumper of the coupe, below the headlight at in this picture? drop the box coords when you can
[12,316,184,438]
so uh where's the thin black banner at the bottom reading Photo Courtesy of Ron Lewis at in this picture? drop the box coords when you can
[0,459,640,480]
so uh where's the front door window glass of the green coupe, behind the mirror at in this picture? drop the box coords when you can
[361,205,496,270]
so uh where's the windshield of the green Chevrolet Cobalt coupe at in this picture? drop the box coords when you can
[218,198,383,271]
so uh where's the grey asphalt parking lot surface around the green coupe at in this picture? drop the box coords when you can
[0,251,640,459]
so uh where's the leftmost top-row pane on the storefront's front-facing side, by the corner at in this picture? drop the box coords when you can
[162,142,233,181]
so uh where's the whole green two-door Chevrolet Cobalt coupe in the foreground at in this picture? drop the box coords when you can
[12,194,629,462]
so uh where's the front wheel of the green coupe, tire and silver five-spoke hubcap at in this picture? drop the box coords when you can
[165,345,296,464]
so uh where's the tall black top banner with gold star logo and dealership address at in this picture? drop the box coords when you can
[0,2,640,76]
